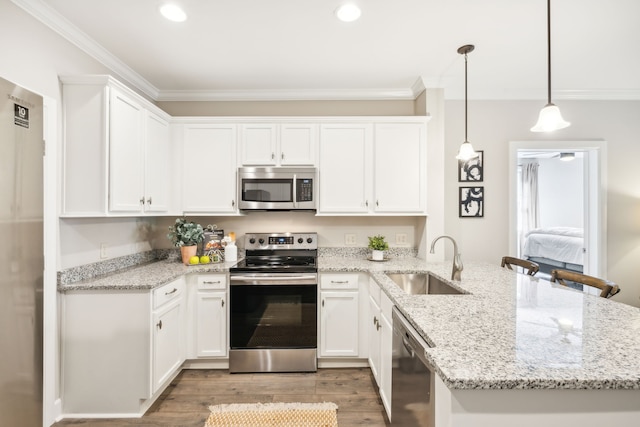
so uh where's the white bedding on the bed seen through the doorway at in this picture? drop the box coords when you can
[522,227,584,265]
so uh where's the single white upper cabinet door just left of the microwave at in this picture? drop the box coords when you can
[182,125,236,213]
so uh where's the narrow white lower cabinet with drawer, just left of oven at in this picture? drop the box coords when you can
[195,274,229,358]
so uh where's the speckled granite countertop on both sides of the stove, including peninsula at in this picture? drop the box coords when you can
[58,256,640,390]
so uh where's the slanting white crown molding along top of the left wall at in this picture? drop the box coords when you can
[11,0,158,99]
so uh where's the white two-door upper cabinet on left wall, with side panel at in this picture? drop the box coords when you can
[61,76,172,216]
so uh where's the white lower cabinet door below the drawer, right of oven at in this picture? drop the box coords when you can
[320,291,358,357]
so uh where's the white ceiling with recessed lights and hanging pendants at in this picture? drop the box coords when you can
[12,0,640,101]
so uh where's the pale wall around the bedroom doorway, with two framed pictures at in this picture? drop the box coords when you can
[445,100,640,306]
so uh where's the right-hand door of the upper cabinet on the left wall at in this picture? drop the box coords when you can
[144,112,171,212]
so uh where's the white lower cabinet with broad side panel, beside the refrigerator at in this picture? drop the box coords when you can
[61,277,186,417]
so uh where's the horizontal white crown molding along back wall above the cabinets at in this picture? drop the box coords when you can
[156,88,419,101]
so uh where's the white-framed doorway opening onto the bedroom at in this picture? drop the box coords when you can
[510,141,606,278]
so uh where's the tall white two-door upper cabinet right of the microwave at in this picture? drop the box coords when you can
[318,120,427,215]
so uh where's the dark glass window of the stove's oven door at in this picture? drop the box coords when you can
[230,285,317,349]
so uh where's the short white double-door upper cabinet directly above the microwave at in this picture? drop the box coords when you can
[240,122,318,166]
